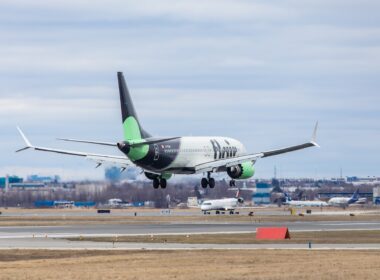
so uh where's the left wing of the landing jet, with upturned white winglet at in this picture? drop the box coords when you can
[16,127,133,168]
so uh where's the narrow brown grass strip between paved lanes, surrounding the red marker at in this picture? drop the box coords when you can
[69,230,380,244]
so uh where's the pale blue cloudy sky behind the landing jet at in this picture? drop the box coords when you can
[0,0,380,180]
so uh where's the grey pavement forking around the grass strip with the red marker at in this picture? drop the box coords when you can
[0,221,380,250]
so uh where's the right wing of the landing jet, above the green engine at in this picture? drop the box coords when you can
[195,122,319,173]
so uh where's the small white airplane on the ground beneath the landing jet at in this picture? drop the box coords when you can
[201,190,244,214]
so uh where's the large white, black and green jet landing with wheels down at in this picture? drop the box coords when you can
[16,72,319,189]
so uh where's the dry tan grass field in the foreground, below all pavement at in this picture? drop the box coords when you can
[0,250,380,280]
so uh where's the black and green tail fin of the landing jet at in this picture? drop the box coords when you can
[117,72,151,140]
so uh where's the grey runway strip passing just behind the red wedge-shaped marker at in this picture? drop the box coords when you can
[0,221,380,239]
